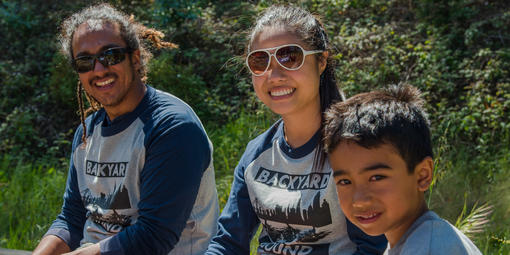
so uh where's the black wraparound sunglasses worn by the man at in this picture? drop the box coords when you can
[73,47,132,73]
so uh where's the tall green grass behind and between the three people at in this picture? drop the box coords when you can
[0,111,510,254]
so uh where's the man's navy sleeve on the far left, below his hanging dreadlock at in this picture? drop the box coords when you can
[45,127,86,250]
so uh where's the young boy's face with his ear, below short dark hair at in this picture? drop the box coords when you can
[329,142,433,245]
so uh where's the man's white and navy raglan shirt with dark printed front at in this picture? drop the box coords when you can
[47,86,219,254]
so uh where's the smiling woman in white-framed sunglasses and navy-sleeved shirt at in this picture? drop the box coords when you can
[207,6,386,254]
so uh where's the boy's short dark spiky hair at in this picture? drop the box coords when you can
[324,85,433,173]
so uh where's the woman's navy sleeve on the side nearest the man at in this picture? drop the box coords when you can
[206,145,260,255]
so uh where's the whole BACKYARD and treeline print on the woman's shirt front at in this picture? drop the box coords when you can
[252,167,332,255]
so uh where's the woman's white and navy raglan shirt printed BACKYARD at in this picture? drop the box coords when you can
[206,121,386,255]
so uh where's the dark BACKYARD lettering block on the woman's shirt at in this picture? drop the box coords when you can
[255,167,330,190]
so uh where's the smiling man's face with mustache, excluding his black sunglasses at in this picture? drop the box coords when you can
[72,23,140,117]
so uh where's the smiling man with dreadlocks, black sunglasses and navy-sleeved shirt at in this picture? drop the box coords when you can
[34,4,219,255]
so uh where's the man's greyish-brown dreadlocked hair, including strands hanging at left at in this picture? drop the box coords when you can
[58,3,178,144]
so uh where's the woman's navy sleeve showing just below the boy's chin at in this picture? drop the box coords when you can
[345,218,388,255]
